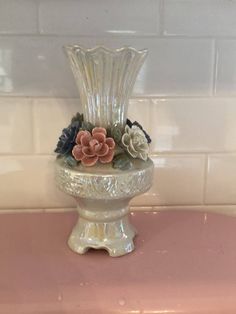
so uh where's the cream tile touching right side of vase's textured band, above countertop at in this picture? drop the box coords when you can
[132,155,205,206]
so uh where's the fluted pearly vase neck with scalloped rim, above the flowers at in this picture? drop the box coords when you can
[65,45,147,128]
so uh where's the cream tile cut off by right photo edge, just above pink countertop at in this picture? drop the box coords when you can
[205,154,236,204]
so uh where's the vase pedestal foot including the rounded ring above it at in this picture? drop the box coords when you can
[68,202,136,257]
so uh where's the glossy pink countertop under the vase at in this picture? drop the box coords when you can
[0,212,236,314]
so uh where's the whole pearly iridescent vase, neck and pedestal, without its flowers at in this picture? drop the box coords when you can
[55,45,153,256]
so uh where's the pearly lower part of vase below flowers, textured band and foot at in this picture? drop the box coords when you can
[55,159,153,256]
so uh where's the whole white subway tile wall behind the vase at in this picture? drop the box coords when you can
[0,0,236,212]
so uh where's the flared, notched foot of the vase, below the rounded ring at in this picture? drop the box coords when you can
[68,209,136,257]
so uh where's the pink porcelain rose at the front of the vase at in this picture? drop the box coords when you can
[72,127,115,166]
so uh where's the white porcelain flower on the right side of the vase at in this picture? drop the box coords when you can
[121,125,149,160]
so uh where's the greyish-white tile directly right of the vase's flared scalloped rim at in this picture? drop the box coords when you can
[120,38,213,96]
